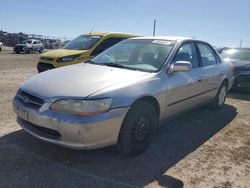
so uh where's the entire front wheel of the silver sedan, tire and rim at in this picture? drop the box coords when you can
[116,102,159,156]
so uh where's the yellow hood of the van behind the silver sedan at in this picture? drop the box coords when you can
[41,49,87,58]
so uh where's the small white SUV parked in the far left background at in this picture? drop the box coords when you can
[13,39,44,54]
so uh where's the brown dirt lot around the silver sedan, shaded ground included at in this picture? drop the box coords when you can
[0,51,250,188]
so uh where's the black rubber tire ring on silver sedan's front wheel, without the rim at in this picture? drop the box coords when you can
[117,102,158,156]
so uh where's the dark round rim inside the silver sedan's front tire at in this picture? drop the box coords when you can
[132,117,150,143]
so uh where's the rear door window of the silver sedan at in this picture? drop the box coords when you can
[198,43,217,66]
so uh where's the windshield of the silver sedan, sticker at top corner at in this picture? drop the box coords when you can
[91,39,175,72]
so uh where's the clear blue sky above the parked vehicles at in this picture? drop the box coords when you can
[0,0,250,47]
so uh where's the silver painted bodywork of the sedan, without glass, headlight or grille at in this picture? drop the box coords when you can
[13,38,234,149]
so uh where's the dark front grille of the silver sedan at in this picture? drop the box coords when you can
[16,90,44,108]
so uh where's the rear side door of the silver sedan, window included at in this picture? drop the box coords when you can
[197,42,223,99]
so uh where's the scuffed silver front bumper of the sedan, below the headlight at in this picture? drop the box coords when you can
[13,99,129,149]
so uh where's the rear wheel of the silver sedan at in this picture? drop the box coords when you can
[211,82,227,110]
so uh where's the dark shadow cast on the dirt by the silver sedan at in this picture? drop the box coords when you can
[0,105,237,188]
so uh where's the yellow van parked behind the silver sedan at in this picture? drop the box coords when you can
[37,32,143,72]
